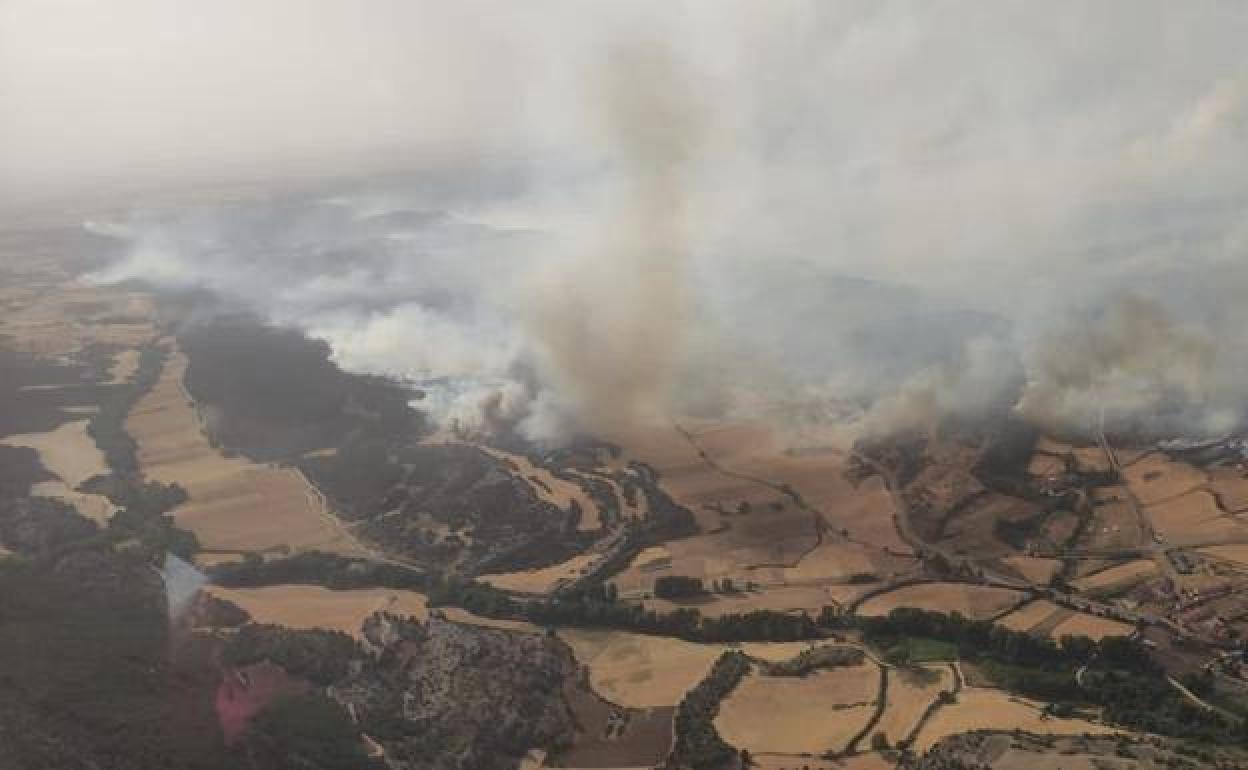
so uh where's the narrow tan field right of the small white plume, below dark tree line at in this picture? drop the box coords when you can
[203,585,428,636]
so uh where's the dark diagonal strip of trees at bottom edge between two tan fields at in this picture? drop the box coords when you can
[668,651,750,770]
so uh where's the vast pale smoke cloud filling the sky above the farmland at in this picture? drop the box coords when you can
[14,0,1248,441]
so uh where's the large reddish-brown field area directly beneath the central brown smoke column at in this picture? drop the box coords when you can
[606,424,912,594]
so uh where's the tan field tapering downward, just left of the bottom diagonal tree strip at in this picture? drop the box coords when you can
[559,629,724,709]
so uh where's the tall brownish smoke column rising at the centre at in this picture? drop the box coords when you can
[527,44,704,438]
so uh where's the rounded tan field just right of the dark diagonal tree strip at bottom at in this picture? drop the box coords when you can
[715,663,880,754]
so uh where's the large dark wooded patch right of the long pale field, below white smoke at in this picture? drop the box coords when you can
[178,318,423,461]
